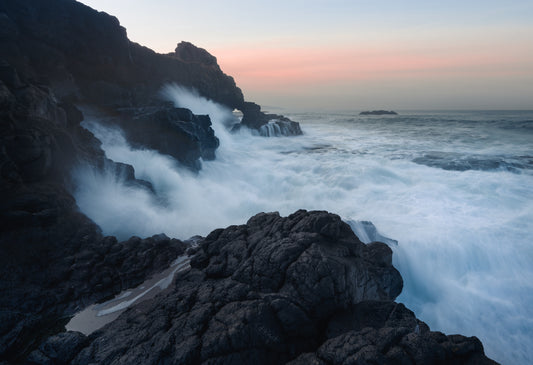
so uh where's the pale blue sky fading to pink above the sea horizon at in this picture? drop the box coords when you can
[82,0,533,111]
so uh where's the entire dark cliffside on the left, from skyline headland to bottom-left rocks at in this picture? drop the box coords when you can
[0,0,300,361]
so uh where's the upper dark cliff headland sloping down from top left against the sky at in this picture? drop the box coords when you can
[0,0,244,109]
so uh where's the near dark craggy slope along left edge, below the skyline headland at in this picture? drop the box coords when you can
[0,56,186,361]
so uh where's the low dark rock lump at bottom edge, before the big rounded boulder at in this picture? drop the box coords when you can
[289,301,497,365]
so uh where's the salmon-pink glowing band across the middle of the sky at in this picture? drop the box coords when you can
[212,41,533,90]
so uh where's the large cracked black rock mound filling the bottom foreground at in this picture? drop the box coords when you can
[26,211,493,364]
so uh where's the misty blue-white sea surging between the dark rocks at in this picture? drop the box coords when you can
[74,87,533,364]
